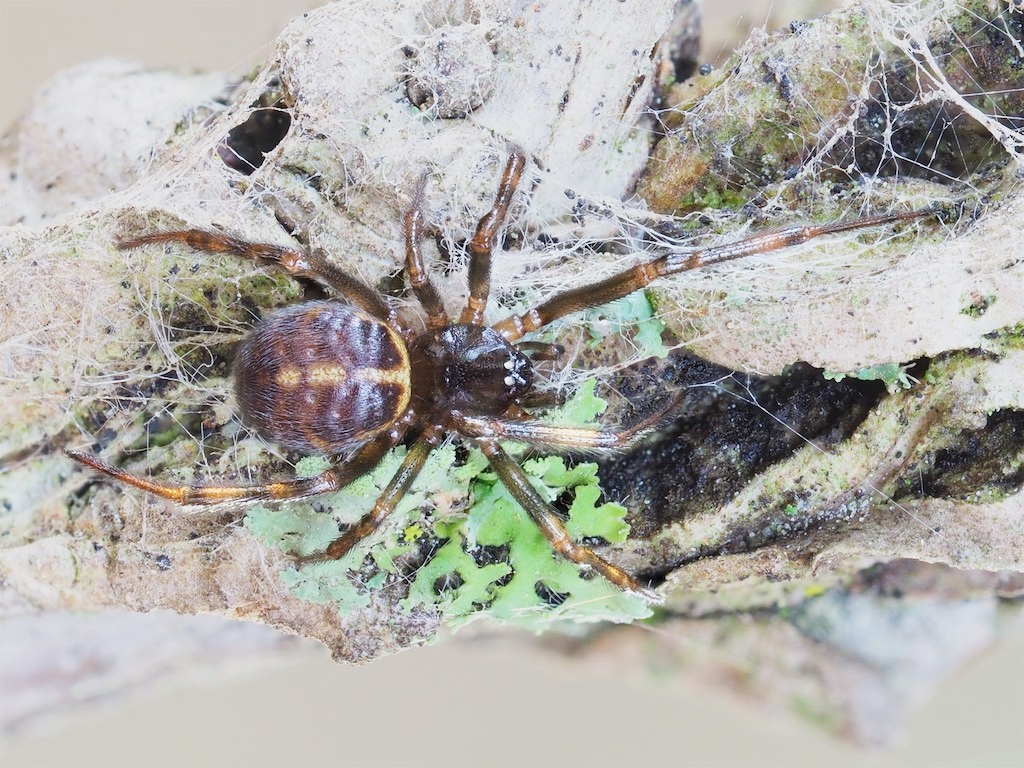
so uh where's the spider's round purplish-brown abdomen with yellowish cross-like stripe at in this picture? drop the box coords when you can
[234,301,410,454]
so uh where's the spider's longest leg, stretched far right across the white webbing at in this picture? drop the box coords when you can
[492,210,932,341]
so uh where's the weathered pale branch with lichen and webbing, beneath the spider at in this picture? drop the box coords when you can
[0,0,1024,737]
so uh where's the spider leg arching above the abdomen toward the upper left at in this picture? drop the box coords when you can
[118,229,395,322]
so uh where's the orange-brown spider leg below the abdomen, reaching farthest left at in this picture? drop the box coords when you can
[65,430,401,506]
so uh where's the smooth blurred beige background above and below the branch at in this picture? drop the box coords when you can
[0,0,1024,766]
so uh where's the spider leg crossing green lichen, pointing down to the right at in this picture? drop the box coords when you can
[475,437,660,601]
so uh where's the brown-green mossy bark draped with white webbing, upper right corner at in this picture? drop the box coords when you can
[637,0,1024,216]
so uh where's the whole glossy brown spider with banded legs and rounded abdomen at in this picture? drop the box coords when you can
[68,150,924,598]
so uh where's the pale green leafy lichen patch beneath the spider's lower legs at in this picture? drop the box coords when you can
[246,382,650,631]
